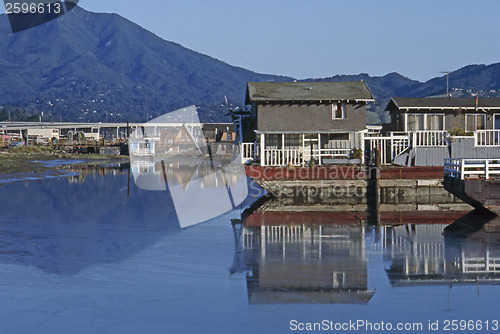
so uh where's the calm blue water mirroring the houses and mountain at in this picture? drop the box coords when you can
[0,170,500,333]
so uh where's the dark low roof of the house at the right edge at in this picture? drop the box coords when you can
[385,97,500,111]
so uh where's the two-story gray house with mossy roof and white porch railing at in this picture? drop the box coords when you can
[243,81,374,166]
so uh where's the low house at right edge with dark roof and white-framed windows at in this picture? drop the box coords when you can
[386,97,500,166]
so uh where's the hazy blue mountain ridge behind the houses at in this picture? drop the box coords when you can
[0,7,500,124]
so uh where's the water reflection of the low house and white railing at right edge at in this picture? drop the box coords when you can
[383,217,500,286]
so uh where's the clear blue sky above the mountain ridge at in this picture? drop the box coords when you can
[2,0,500,81]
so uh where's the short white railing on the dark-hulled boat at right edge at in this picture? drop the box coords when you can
[444,158,500,180]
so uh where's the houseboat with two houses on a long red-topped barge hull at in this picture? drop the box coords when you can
[233,81,500,211]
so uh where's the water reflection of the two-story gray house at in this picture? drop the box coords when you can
[231,213,374,304]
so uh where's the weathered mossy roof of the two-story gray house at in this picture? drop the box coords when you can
[245,81,374,104]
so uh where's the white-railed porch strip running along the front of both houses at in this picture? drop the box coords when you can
[240,130,500,166]
